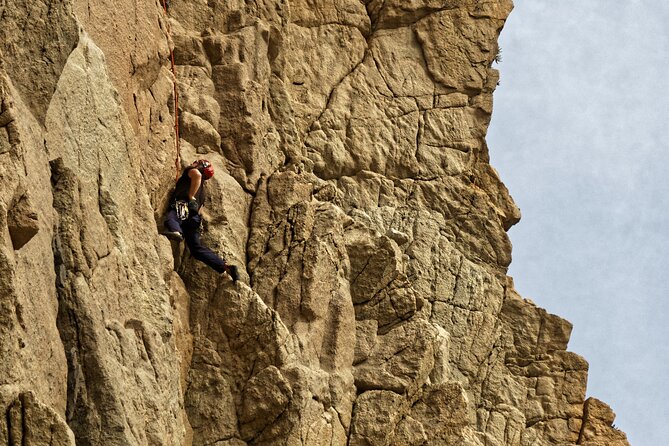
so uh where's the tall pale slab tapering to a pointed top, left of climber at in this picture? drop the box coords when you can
[43,29,184,444]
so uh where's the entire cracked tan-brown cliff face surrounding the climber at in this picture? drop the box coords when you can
[0,0,628,446]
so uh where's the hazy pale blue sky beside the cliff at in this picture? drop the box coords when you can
[488,0,669,446]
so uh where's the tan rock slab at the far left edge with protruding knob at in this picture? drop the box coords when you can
[0,69,67,418]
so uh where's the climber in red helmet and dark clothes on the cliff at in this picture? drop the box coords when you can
[163,159,239,282]
